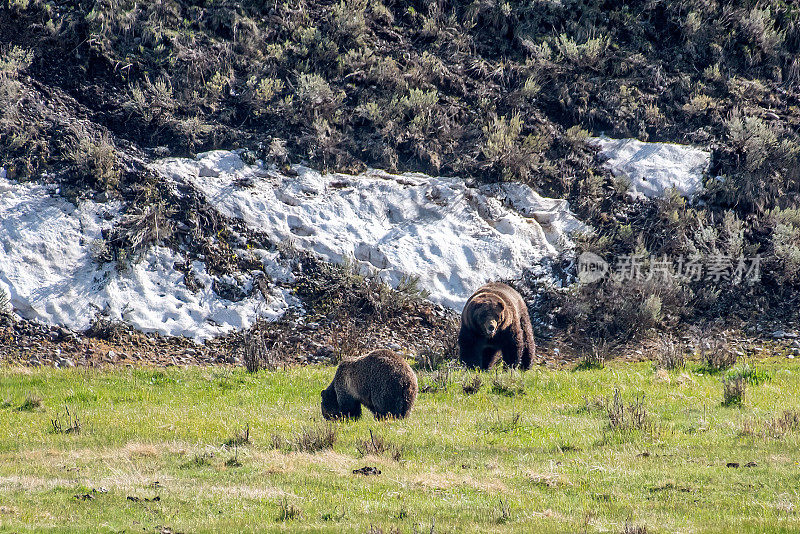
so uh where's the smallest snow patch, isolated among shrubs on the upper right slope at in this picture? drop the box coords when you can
[592,137,711,198]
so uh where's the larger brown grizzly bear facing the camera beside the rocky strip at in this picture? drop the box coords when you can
[458,282,536,369]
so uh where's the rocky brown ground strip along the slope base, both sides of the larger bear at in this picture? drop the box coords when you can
[0,312,800,374]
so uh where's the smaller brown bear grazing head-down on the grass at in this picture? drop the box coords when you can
[322,349,418,419]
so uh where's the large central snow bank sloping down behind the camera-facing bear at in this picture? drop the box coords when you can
[155,151,584,310]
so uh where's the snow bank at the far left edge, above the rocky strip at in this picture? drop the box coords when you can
[0,178,288,341]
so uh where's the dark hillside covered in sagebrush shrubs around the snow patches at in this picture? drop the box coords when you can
[0,0,800,354]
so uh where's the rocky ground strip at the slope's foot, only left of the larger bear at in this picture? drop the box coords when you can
[0,305,457,367]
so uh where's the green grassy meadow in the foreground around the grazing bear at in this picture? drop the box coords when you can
[0,361,800,532]
